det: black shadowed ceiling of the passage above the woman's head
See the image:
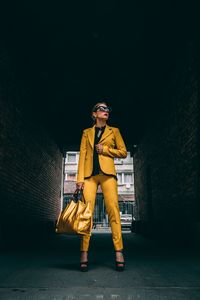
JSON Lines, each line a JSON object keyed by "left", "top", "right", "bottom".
{"left": 0, "top": 0, "right": 195, "bottom": 150}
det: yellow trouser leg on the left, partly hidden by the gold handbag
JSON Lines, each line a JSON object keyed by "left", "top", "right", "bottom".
{"left": 80, "top": 175, "right": 98, "bottom": 251}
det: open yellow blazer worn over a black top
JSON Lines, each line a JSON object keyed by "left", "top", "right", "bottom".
{"left": 77, "top": 124, "right": 127, "bottom": 182}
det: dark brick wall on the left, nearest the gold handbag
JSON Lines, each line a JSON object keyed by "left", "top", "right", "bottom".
{"left": 0, "top": 48, "right": 63, "bottom": 246}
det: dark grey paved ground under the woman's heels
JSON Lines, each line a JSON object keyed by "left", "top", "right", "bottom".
{"left": 0, "top": 231, "right": 200, "bottom": 300}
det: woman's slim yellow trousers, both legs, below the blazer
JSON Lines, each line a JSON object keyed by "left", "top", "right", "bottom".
{"left": 80, "top": 173, "right": 123, "bottom": 251}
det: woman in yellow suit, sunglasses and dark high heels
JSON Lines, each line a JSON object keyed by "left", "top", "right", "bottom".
{"left": 76, "top": 102, "right": 127, "bottom": 271}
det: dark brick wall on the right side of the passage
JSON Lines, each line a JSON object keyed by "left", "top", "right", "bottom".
{"left": 134, "top": 45, "right": 200, "bottom": 238}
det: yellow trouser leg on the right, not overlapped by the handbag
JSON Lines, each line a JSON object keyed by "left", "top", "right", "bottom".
{"left": 100, "top": 175, "right": 123, "bottom": 250}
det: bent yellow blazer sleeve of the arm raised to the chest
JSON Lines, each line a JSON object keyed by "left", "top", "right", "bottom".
{"left": 102, "top": 128, "right": 127, "bottom": 158}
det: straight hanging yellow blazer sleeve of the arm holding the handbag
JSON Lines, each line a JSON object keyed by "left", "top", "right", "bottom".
{"left": 76, "top": 130, "right": 86, "bottom": 182}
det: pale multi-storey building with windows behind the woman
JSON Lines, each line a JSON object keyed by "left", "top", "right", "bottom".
{"left": 63, "top": 151, "right": 135, "bottom": 228}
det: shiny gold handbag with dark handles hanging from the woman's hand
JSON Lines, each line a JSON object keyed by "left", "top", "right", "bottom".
{"left": 55, "top": 189, "right": 92, "bottom": 235}
